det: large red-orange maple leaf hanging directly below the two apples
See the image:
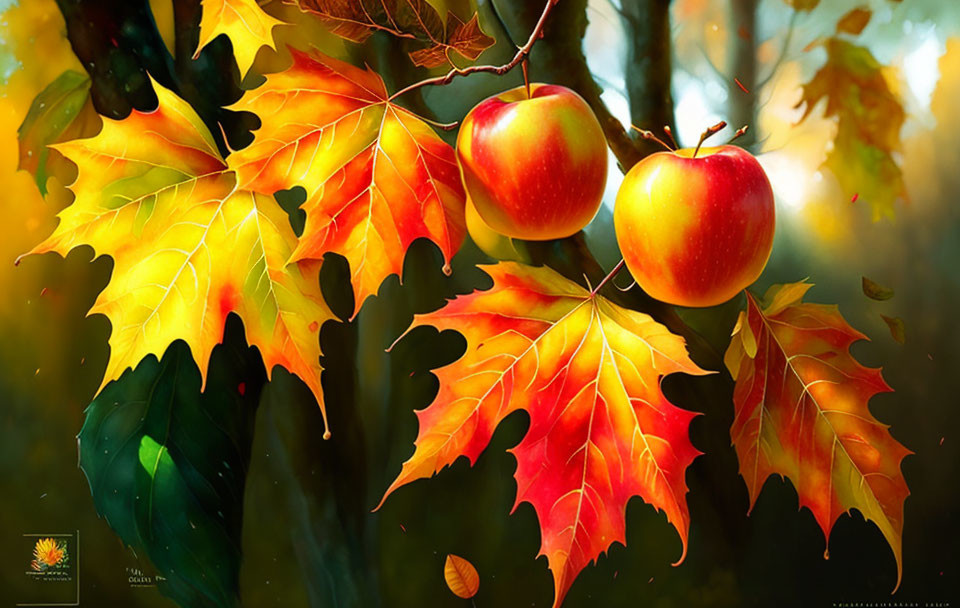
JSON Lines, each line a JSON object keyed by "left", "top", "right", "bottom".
{"left": 381, "top": 262, "right": 707, "bottom": 606}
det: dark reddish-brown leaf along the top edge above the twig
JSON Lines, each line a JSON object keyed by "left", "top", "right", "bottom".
{"left": 298, "top": 0, "right": 495, "bottom": 68}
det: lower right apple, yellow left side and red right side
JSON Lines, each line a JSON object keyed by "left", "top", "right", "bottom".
{"left": 613, "top": 145, "right": 776, "bottom": 306}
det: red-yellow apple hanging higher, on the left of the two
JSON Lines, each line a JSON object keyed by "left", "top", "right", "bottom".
{"left": 457, "top": 84, "right": 607, "bottom": 240}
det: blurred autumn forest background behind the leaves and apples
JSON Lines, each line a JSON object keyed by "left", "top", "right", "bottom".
{"left": 0, "top": 0, "right": 960, "bottom": 608}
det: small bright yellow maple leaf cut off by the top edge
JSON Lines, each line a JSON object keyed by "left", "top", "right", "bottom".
{"left": 193, "top": 0, "right": 283, "bottom": 78}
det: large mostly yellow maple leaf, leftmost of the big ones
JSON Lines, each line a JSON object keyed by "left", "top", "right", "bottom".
{"left": 24, "top": 82, "right": 333, "bottom": 432}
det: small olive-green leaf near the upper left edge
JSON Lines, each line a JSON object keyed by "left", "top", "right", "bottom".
{"left": 17, "top": 70, "right": 97, "bottom": 196}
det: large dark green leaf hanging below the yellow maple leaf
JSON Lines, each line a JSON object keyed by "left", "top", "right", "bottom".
{"left": 79, "top": 320, "right": 265, "bottom": 608}
